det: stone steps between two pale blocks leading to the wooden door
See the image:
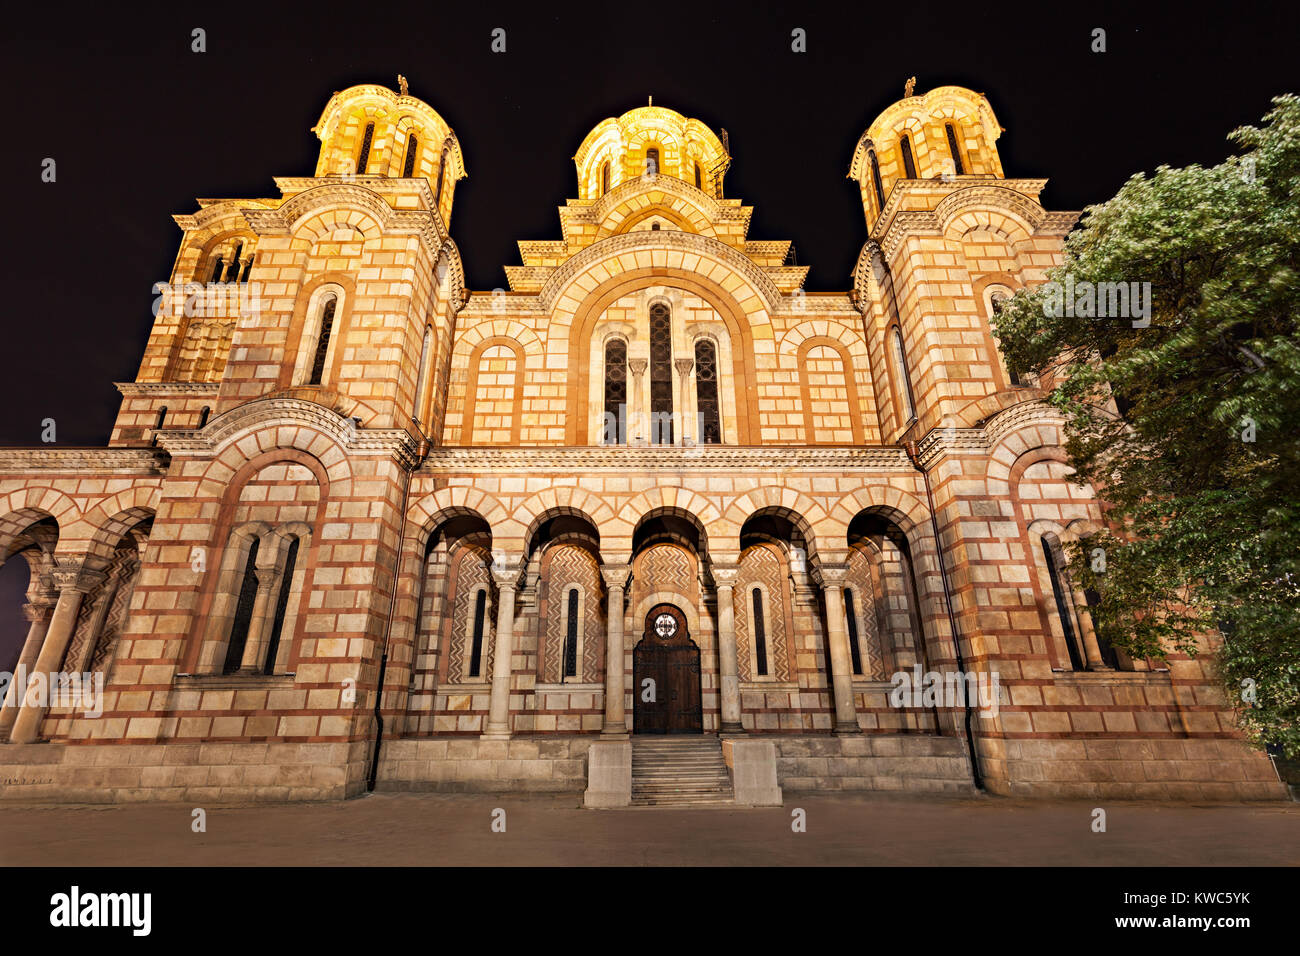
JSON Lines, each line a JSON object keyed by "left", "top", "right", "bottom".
{"left": 632, "top": 734, "right": 736, "bottom": 806}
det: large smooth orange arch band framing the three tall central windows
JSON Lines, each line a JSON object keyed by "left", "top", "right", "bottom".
{"left": 553, "top": 267, "right": 761, "bottom": 445}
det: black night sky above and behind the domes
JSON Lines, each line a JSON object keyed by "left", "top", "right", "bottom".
{"left": 0, "top": 0, "right": 1300, "bottom": 650}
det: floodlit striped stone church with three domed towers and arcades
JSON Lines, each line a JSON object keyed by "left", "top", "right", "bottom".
{"left": 0, "top": 79, "right": 1286, "bottom": 806}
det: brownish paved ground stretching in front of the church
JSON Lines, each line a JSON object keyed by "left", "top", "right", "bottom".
{"left": 0, "top": 793, "right": 1300, "bottom": 866}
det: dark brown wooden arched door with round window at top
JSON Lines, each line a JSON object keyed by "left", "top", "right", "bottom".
{"left": 632, "top": 604, "right": 705, "bottom": 734}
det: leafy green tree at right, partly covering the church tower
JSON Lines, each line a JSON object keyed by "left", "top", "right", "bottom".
{"left": 996, "top": 95, "right": 1300, "bottom": 756}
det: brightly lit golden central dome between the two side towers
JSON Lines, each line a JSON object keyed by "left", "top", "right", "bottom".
{"left": 573, "top": 105, "right": 731, "bottom": 199}
